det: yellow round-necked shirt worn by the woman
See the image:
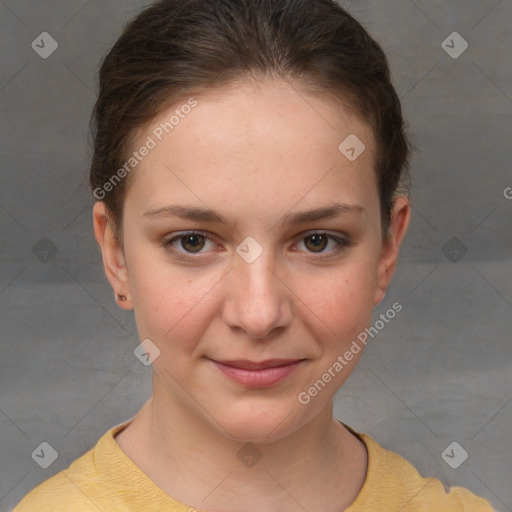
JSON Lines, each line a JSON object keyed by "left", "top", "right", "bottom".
{"left": 12, "top": 420, "right": 494, "bottom": 512}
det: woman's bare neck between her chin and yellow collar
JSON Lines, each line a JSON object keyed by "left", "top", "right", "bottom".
{"left": 123, "top": 373, "right": 367, "bottom": 512}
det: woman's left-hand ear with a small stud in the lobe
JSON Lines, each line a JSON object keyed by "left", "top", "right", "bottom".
{"left": 93, "top": 201, "right": 133, "bottom": 310}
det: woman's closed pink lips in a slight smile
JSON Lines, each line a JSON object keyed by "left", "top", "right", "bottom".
{"left": 211, "top": 359, "right": 304, "bottom": 388}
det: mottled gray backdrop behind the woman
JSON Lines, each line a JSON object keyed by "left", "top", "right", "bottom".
{"left": 0, "top": 0, "right": 512, "bottom": 512}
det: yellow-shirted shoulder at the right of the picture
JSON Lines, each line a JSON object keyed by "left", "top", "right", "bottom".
{"left": 347, "top": 434, "right": 494, "bottom": 512}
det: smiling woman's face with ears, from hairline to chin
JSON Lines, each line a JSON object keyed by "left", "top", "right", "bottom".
{"left": 94, "top": 78, "right": 408, "bottom": 441}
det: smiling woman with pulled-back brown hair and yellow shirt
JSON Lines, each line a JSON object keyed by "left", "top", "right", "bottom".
{"left": 15, "top": 0, "right": 492, "bottom": 512}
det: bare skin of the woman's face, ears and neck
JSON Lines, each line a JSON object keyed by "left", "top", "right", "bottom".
{"left": 93, "top": 80, "right": 410, "bottom": 512}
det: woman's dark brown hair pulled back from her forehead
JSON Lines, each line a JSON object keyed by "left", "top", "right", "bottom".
{"left": 90, "top": 0, "right": 410, "bottom": 238}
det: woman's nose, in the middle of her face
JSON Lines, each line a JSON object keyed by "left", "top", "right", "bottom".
{"left": 223, "top": 245, "right": 293, "bottom": 339}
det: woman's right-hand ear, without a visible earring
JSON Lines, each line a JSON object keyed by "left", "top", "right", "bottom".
{"left": 373, "top": 195, "right": 411, "bottom": 305}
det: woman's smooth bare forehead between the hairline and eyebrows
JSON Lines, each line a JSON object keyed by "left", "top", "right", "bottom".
{"left": 123, "top": 80, "right": 376, "bottom": 223}
